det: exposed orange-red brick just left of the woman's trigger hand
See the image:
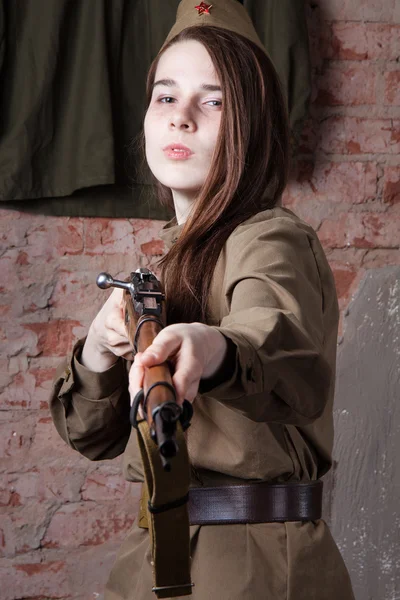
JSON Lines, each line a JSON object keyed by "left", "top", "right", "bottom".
{"left": 24, "top": 319, "right": 81, "bottom": 356}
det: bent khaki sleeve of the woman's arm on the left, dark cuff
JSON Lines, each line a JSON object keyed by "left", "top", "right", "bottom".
{"left": 50, "top": 339, "right": 131, "bottom": 460}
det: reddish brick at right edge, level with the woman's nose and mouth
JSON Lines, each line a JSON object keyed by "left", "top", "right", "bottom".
{"left": 319, "top": 116, "right": 400, "bottom": 154}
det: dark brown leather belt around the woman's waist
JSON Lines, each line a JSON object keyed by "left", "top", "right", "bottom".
{"left": 139, "top": 480, "right": 323, "bottom": 528}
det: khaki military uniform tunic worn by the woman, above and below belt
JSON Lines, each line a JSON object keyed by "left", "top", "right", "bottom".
{"left": 51, "top": 207, "right": 353, "bottom": 600}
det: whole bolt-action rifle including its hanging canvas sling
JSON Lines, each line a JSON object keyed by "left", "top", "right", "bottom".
{"left": 97, "top": 268, "right": 194, "bottom": 598}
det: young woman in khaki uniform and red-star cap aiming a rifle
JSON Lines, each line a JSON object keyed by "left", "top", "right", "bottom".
{"left": 51, "top": 0, "right": 353, "bottom": 600}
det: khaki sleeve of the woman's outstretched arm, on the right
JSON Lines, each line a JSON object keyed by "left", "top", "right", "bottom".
{"left": 199, "top": 218, "right": 336, "bottom": 425}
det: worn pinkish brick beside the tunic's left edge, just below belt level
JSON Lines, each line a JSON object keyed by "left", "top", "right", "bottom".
{"left": 42, "top": 502, "right": 134, "bottom": 550}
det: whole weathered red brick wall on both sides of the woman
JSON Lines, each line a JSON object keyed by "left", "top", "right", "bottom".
{"left": 0, "top": 0, "right": 400, "bottom": 600}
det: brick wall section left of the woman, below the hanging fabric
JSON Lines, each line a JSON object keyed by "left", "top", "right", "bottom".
{"left": 0, "top": 210, "right": 163, "bottom": 600}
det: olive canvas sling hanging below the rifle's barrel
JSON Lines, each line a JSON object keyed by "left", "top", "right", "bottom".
{"left": 137, "top": 420, "right": 193, "bottom": 598}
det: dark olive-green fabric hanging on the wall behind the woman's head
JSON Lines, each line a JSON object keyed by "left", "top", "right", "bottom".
{"left": 0, "top": 0, "right": 310, "bottom": 219}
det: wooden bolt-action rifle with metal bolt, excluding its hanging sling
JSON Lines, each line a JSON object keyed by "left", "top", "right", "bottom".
{"left": 97, "top": 268, "right": 193, "bottom": 471}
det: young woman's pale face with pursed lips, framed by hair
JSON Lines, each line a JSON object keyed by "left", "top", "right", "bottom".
{"left": 144, "top": 40, "right": 222, "bottom": 198}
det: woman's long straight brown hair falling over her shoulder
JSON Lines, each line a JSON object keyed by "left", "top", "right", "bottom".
{"left": 146, "top": 27, "right": 289, "bottom": 324}
